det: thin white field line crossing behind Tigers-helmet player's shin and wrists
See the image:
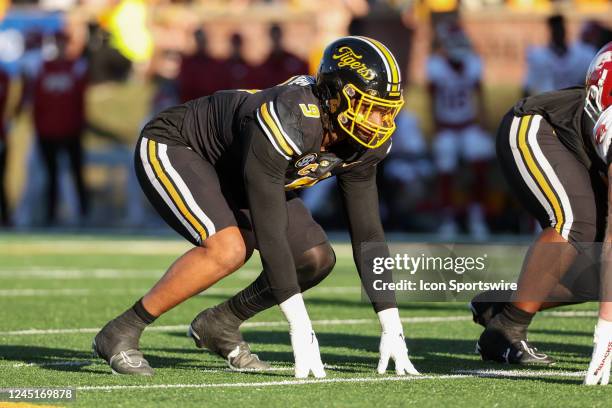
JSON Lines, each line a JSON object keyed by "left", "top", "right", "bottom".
{"left": 0, "top": 286, "right": 361, "bottom": 297}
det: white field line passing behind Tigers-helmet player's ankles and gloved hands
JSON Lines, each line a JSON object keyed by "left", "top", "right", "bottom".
{"left": 0, "top": 316, "right": 471, "bottom": 336}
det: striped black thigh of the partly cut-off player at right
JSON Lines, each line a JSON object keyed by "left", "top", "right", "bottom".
{"left": 497, "top": 113, "right": 598, "bottom": 244}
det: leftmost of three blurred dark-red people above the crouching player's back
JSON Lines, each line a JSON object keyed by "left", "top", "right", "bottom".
{"left": 177, "top": 29, "right": 228, "bottom": 102}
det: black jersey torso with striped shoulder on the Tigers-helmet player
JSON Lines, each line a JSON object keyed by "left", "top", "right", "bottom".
{"left": 146, "top": 76, "right": 391, "bottom": 190}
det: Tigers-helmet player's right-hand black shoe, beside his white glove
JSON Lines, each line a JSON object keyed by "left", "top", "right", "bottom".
{"left": 187, "top": 303, "right": 270, "bottom": 370}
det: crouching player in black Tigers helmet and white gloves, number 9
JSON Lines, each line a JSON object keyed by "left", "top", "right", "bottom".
{"left": 93, "top": 37, "right": 416, "bottom": 377}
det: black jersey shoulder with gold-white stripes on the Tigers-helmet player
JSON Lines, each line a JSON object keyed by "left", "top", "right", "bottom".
{"left": 256, "top": 87, "right": 323, "bottom": 160}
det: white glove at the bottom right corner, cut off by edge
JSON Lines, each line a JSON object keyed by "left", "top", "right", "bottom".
{"left": 584, "top": 319, "right": 612, "bottom": 385}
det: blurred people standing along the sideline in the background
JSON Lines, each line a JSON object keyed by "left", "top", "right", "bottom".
{"left": 0, "top": 0, "right": 610, "bottom": 240}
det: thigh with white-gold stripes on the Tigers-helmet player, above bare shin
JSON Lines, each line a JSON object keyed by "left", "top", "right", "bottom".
{"left": 135, "top": 136, "right": 236, "bottom": 245}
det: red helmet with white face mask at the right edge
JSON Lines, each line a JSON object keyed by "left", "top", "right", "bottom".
{"left": 584, "top": 42, "right": 612, "bottom": 123}
